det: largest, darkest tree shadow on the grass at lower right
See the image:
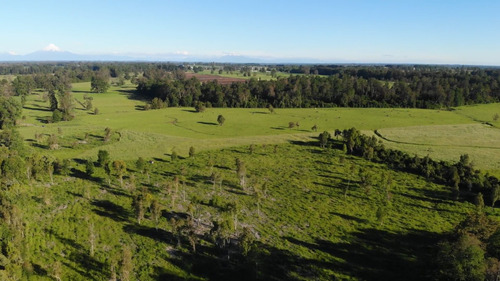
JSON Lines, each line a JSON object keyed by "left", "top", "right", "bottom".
{"left": 286, "top": 229, "right": 440, "bottom": 280}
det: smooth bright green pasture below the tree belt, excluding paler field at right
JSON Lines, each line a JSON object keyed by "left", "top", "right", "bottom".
{"left": 20, "top": 83, "right": 486, "bottom": 164}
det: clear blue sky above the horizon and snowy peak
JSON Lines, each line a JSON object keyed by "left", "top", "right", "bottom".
{"left": 0, "top": 0, "right": 500, "bottom": 65}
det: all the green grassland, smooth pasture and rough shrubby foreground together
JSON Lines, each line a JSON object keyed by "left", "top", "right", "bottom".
{"left": 0, "top": 80, "right": 500, "bottom": 281}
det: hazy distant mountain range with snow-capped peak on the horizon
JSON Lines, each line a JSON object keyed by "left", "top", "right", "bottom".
{"left": 0, "top": 47, "right": 324, "bottom": 64}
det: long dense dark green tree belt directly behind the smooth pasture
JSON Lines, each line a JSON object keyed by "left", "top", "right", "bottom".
{"left": 137, "top": 68, "right": 500, "bottom": 108}
